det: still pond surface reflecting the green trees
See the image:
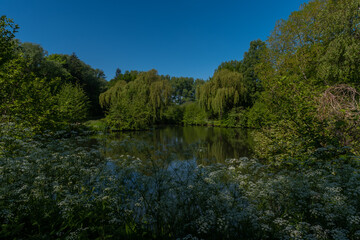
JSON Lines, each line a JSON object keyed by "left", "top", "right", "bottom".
{"left": 97, "top": 126, "right": 252, "bottom": 165}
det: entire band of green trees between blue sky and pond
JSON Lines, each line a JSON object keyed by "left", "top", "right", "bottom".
{"left": 0, "top": 0, "right": 360, "bottom": 156}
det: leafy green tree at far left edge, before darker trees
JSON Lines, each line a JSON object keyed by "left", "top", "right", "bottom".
{"left": 0, "top": 54, "right": 57, "bottom": 130}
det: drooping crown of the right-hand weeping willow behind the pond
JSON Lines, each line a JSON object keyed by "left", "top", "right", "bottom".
{"left": 198, "top": 69, "right": 248, "bottom": 118}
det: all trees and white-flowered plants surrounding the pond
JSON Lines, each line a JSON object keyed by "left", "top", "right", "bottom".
{"left": 0, "top": 0, "right": 360, "bottom": 239}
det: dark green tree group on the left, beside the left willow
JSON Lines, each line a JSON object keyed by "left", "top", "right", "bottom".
{"left": 0, "top": 16, "right": 107, "bottom": 131}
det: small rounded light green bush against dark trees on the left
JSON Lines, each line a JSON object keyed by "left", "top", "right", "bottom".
{"left": 56, "top": 83, "right": 89, "bottom": 123}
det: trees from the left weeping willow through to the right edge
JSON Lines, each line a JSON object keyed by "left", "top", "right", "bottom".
{"left": 100, "top": 0, "right": 360, "bottom": 157}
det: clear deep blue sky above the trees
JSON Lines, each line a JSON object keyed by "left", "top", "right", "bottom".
{"left": 0, "top": 0, "right": 308, "bottom": 80}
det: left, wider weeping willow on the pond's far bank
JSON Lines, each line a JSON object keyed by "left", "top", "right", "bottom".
{"left": 100, "top": 70, "right": 172, "bottom": 130}
